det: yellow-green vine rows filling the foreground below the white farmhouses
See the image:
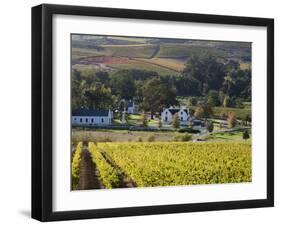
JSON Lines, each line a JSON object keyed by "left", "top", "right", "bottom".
{"left": 72, "top": 142, "right": 252, "bottom": 188}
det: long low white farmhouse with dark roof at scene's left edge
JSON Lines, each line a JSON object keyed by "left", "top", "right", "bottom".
{"left": 72, "top": 108, "right": 113, "bottom": 126}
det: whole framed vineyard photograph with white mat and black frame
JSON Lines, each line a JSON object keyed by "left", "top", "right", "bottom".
{"left": 32, "top": 4, "right": 274, "bottom": 221}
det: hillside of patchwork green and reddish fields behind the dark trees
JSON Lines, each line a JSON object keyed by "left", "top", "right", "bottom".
{"left": 72, "top": 35, "right": 251, "bottom": 75}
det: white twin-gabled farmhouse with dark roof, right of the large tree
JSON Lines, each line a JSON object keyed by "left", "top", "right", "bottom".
{"left": 161, "top": 106, "right": 190, "bottom": 124}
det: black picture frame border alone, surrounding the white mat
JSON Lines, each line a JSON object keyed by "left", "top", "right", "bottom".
{"left": 32, "top": 4, "right": 274, "bottom": 221}
